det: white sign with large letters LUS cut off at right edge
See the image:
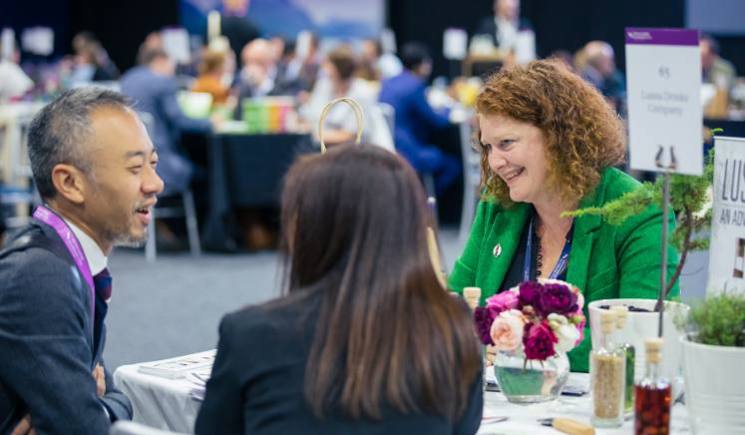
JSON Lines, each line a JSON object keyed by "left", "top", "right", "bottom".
{"left": 707, "top": 137, "right": 745, "bottom": 294}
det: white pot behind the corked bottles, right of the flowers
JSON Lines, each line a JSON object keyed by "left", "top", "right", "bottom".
{"left": 587, "top": 299, "right": 690, "bottom": 384}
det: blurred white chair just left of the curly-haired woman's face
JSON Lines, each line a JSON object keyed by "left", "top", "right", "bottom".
{"left": 458, "top": 116, "right": 481, "bottom": 246}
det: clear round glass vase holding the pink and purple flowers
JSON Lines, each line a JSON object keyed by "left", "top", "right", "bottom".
{"left": 494, "top": 351, "right": 569, "bottom": 404}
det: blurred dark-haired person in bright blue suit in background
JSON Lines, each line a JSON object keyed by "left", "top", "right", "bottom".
{"left": 379, "top": 42, "right": 462, "bottom": 191}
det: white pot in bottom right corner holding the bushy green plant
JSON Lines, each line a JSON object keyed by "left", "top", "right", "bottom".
{"left": 680, "top": 336, "right": 745, "bottom": 435}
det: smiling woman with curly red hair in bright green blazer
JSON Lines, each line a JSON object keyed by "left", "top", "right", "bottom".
{"left": 450, "top": 60, "right": 677, "bottom": 371}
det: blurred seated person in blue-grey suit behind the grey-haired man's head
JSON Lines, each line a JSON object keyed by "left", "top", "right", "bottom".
{"left": 121, "top": 48, "right": 212, "bottom": 196}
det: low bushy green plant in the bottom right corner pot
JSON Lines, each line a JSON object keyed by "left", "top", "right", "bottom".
{"left": 688, "top": 293, "right": 745, "bottom": 347}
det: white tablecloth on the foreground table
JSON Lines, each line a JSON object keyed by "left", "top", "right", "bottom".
{"left": 114, "top": 354, "right": 689, "bottom": 435}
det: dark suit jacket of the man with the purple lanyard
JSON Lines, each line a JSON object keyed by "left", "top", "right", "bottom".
{"left": 0, "top": 221, "right": 132, "bottom": 435}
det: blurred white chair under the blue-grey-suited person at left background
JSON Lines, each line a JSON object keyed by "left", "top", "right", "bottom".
{"left": 139, "top": 112, "right": 202, "bottom": 262}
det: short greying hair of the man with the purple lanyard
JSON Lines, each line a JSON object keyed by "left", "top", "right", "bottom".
{"left": 28, "top": 86, "right": 132, "bottom": 199}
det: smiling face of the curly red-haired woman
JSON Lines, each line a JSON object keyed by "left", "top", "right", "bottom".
{"left": 479, "top": 114, "right": 555, "bottom": 204}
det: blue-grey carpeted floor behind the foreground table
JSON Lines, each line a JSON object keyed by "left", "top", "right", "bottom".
{"left": 105, "top": 229, "right": 708, "bottom": 371}
